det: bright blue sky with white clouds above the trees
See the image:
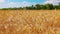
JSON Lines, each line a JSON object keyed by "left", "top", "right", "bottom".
{"left": 0, "top": 0, "right": 60, "bottom": 8}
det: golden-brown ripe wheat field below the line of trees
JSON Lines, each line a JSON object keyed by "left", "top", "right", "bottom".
{"left": 0, "top": 10, "right": 60, "bottom": 34}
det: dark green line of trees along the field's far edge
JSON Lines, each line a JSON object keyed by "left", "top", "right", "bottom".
{"left": 1, "top": 3, "right": 60, "bottom": 10}
